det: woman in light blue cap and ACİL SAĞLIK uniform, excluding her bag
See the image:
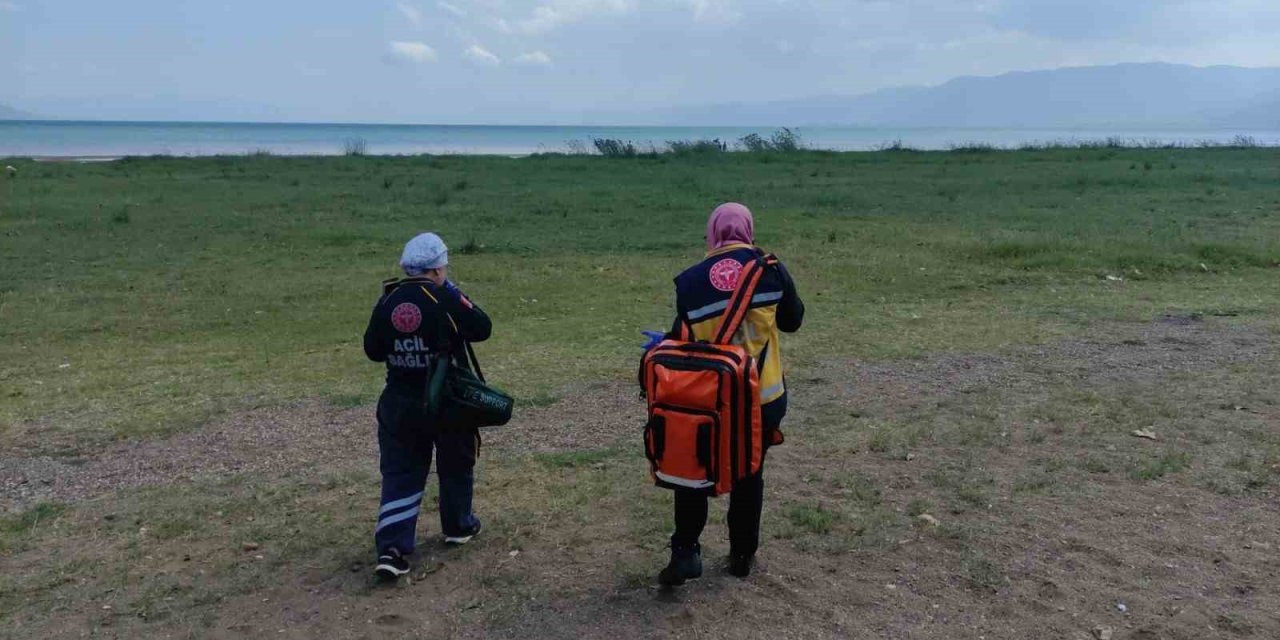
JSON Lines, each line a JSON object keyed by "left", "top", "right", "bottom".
{"left": 365, "top": 233, "right": 492, "bottom": 579}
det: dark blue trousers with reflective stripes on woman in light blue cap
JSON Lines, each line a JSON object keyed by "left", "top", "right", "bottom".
{"left": 374, "top": 389, "right": 480, "bottom": 554}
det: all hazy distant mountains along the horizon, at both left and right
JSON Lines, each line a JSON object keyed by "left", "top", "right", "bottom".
{"left": 0, "top": 63, "right": 1280, "bottom": 131}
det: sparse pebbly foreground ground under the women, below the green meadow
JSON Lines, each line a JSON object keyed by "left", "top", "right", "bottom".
{"left": 0, "top": 317, "right": 1280, "bottom": 639}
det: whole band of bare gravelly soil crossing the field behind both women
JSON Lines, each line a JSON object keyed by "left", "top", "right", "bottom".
{"left": 0, "top": 321, "right": 1274, "bottom": 512}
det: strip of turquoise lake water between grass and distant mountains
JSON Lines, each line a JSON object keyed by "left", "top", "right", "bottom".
{"left": 0, "top": 120, "right": 1280, "bottom": 157}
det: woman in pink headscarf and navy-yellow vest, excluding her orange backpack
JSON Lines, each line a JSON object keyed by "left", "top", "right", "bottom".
{"left": 658, "top": 202, "right": 804, "bottom": 586}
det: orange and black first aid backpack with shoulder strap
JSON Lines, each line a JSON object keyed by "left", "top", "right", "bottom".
{"left": 640, "top": 255, "right": 778, "bottom": 495}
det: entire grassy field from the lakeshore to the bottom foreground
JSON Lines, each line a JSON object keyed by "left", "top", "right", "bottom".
{"left": 0, "top": 148, "right": 1280, "bottom": 637}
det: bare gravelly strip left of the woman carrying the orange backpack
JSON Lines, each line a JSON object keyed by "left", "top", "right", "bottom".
{"left": 0, "top": 383, "right": 644, "bottom": 513}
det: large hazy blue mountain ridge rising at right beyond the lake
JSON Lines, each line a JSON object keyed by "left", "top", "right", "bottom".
{"left": 636, "top": 63, "right": 1280, "bottom": 129}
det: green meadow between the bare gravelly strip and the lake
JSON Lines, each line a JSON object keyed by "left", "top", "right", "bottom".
{"left": 0, "top": 148, "right": 1280, "bottom": 440}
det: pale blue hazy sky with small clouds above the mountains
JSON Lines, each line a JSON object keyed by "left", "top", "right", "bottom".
{"left": 0, "top": 0, "right": 1280, "bottom": 123}
